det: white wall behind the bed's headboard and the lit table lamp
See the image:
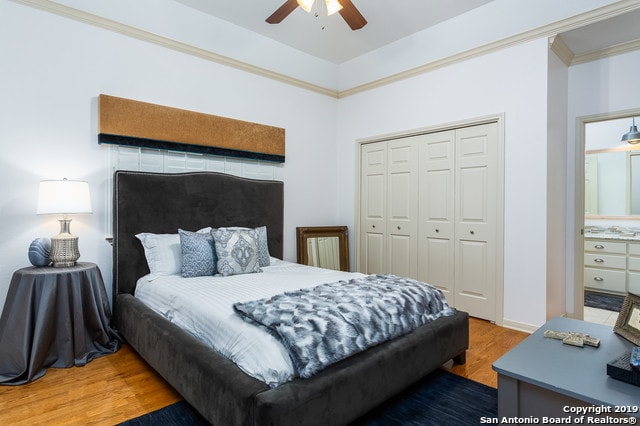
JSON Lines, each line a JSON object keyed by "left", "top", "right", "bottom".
{"left": 0, "top": 1, "right": 339, "bottom": 312}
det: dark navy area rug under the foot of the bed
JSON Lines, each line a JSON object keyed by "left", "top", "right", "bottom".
{"left": 116, "top": 370, "right": 498, "bottom": 426}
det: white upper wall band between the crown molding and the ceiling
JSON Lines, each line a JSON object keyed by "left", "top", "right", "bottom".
{"left": 33, "top": 0, "right": 623, "bottom": 91}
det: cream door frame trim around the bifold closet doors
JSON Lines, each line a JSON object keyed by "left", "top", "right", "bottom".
{"left": 354, "top": 113, "right": 505, "bottom": 326}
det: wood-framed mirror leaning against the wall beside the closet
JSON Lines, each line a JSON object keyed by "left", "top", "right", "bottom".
{"left": 296, "top": 226, "right": 349, "bottom": 271}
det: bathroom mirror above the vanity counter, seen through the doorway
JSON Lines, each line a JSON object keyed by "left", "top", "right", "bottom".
{"left": 584, "top": 118, "right": 640, "bottom": 219}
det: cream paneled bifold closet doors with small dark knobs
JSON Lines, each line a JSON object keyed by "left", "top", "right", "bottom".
{"left": 357, "top": 122, "right": 503, "bottom": 321}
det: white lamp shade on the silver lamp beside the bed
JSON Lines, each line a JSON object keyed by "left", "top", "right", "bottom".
{"left": 37, "top": 179, "right": 91, "bottom": 214}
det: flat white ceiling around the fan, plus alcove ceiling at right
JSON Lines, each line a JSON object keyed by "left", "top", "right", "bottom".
{"left": 175, "top": 0, "right": 640, "bottom": 64}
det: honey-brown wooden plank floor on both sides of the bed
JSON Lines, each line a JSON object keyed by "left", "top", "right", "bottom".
{"left": 0, "top": 318, "right": 528, "bottom": 426}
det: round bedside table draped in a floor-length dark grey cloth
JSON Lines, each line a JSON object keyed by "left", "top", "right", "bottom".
{"left": 0, "top": 263, "right": 120, "bottom": 385}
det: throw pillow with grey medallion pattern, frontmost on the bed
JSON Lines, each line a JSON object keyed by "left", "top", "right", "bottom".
{"left": 211, "top": 228, "right": 262, "bottom": 277}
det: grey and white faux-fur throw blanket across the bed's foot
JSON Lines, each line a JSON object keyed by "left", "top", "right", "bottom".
{"left": 233, "top": 275, "right": 455, "bottom": 378}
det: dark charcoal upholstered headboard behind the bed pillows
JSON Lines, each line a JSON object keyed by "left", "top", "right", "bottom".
{"left": 113, "top": 171, "right": 284, "bottom": 300}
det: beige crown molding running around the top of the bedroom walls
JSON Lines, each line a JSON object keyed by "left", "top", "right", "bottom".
{"left": 11, "top": 0, "right": 640, "bottom": 98}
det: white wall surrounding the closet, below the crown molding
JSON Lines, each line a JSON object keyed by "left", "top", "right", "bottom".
{"left": 338, "top": 39, "right": 547, "bottom": 326}
